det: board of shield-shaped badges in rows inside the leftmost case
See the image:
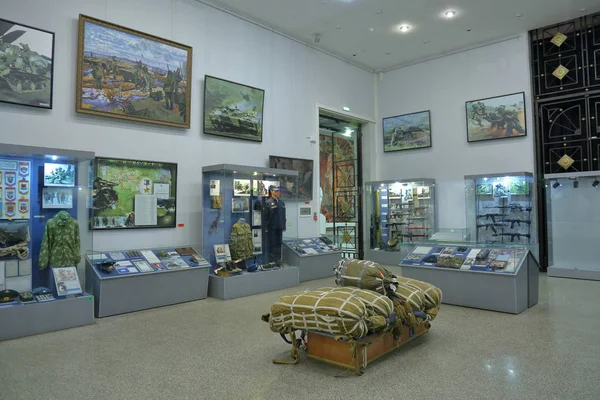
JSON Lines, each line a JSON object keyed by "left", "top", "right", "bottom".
{"left": 0, "top": 159, "right": 31, "bottom": 220}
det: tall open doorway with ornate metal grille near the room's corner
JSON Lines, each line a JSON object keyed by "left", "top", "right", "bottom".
{"left": 319, "top": 112, "right": 363, "bottom": 259}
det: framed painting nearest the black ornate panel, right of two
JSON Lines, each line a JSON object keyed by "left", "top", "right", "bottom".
{"left": 466, "top": 92, "right": 527, "bottom": 142}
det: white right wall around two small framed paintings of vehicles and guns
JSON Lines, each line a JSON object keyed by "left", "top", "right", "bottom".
{"left": 375, "top": 34, "right": 534, "bottom": 228}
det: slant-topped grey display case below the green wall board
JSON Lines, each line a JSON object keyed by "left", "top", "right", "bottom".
{"left": 86, "top": 246, "right": 210, "bottom": 318}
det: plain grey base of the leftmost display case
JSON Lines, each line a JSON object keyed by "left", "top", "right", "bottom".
{"left": 0, "top": 293, "right": 94, "bottom": 340}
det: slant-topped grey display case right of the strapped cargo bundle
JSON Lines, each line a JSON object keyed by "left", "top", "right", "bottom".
{"left": 400, "top": 243, "right": 539, "bottom": 314}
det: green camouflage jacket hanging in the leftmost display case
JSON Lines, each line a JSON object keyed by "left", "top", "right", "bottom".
{"left": 39, "top": 211, "right": 81, "bottom": 269}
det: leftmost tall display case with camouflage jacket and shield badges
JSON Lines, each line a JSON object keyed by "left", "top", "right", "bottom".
{"left": 0, "top": 144, "right": 94, "bottom": 340}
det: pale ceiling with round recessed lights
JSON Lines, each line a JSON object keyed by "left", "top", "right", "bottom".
{"left": 198, "top": 0, "right": 600, "bottom": 71}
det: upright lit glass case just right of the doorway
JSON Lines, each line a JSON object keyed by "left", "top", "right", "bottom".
{"left": 365, "top": 178, "right": 437, "bottom": 251}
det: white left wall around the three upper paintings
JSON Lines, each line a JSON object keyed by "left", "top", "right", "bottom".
{"left": 0, "top": 0, "right": 375, "bottom": 249}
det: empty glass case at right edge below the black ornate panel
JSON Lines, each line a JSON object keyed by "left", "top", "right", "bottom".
{"left": 545, "top": 172, "right": 600, "bottom": 280}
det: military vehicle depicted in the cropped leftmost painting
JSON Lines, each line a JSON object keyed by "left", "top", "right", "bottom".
{"left": 0, "top": 41, "right": 51, "bottom": 93}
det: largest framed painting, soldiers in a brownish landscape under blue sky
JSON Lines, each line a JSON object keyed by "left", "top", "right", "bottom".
{"left": 77, "top": 15, "right": 192, "bottom": 128}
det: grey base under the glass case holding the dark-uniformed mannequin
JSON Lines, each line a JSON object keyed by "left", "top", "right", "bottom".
{"left": 208, "top": 267, "right": 298, "bottom": 300}
